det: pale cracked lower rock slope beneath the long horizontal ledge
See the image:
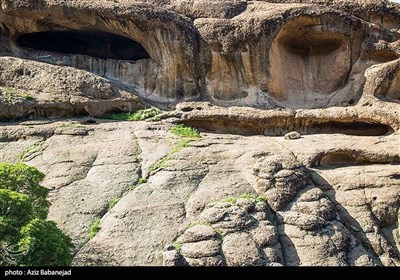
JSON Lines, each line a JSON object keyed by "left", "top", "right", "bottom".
{"left": 0, "top": 117, "right": 400, "bottom": 266}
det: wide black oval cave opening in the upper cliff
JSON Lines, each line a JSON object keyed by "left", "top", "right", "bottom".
{"left": 17, "top": 30, "right": 150, "bottom": 61}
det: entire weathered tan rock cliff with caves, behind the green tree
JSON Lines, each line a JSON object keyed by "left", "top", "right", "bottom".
{"left": 0, "top": 0, "right": 400, "bottom": 266}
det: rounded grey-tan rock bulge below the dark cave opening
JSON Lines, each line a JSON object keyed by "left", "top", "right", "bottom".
{"left": 0, "top": 57, "right": 145, "bottom": 120}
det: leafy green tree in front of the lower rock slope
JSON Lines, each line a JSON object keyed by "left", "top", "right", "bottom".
{"left": 0, "top": 163, "right": 72, "bottom": 266}
